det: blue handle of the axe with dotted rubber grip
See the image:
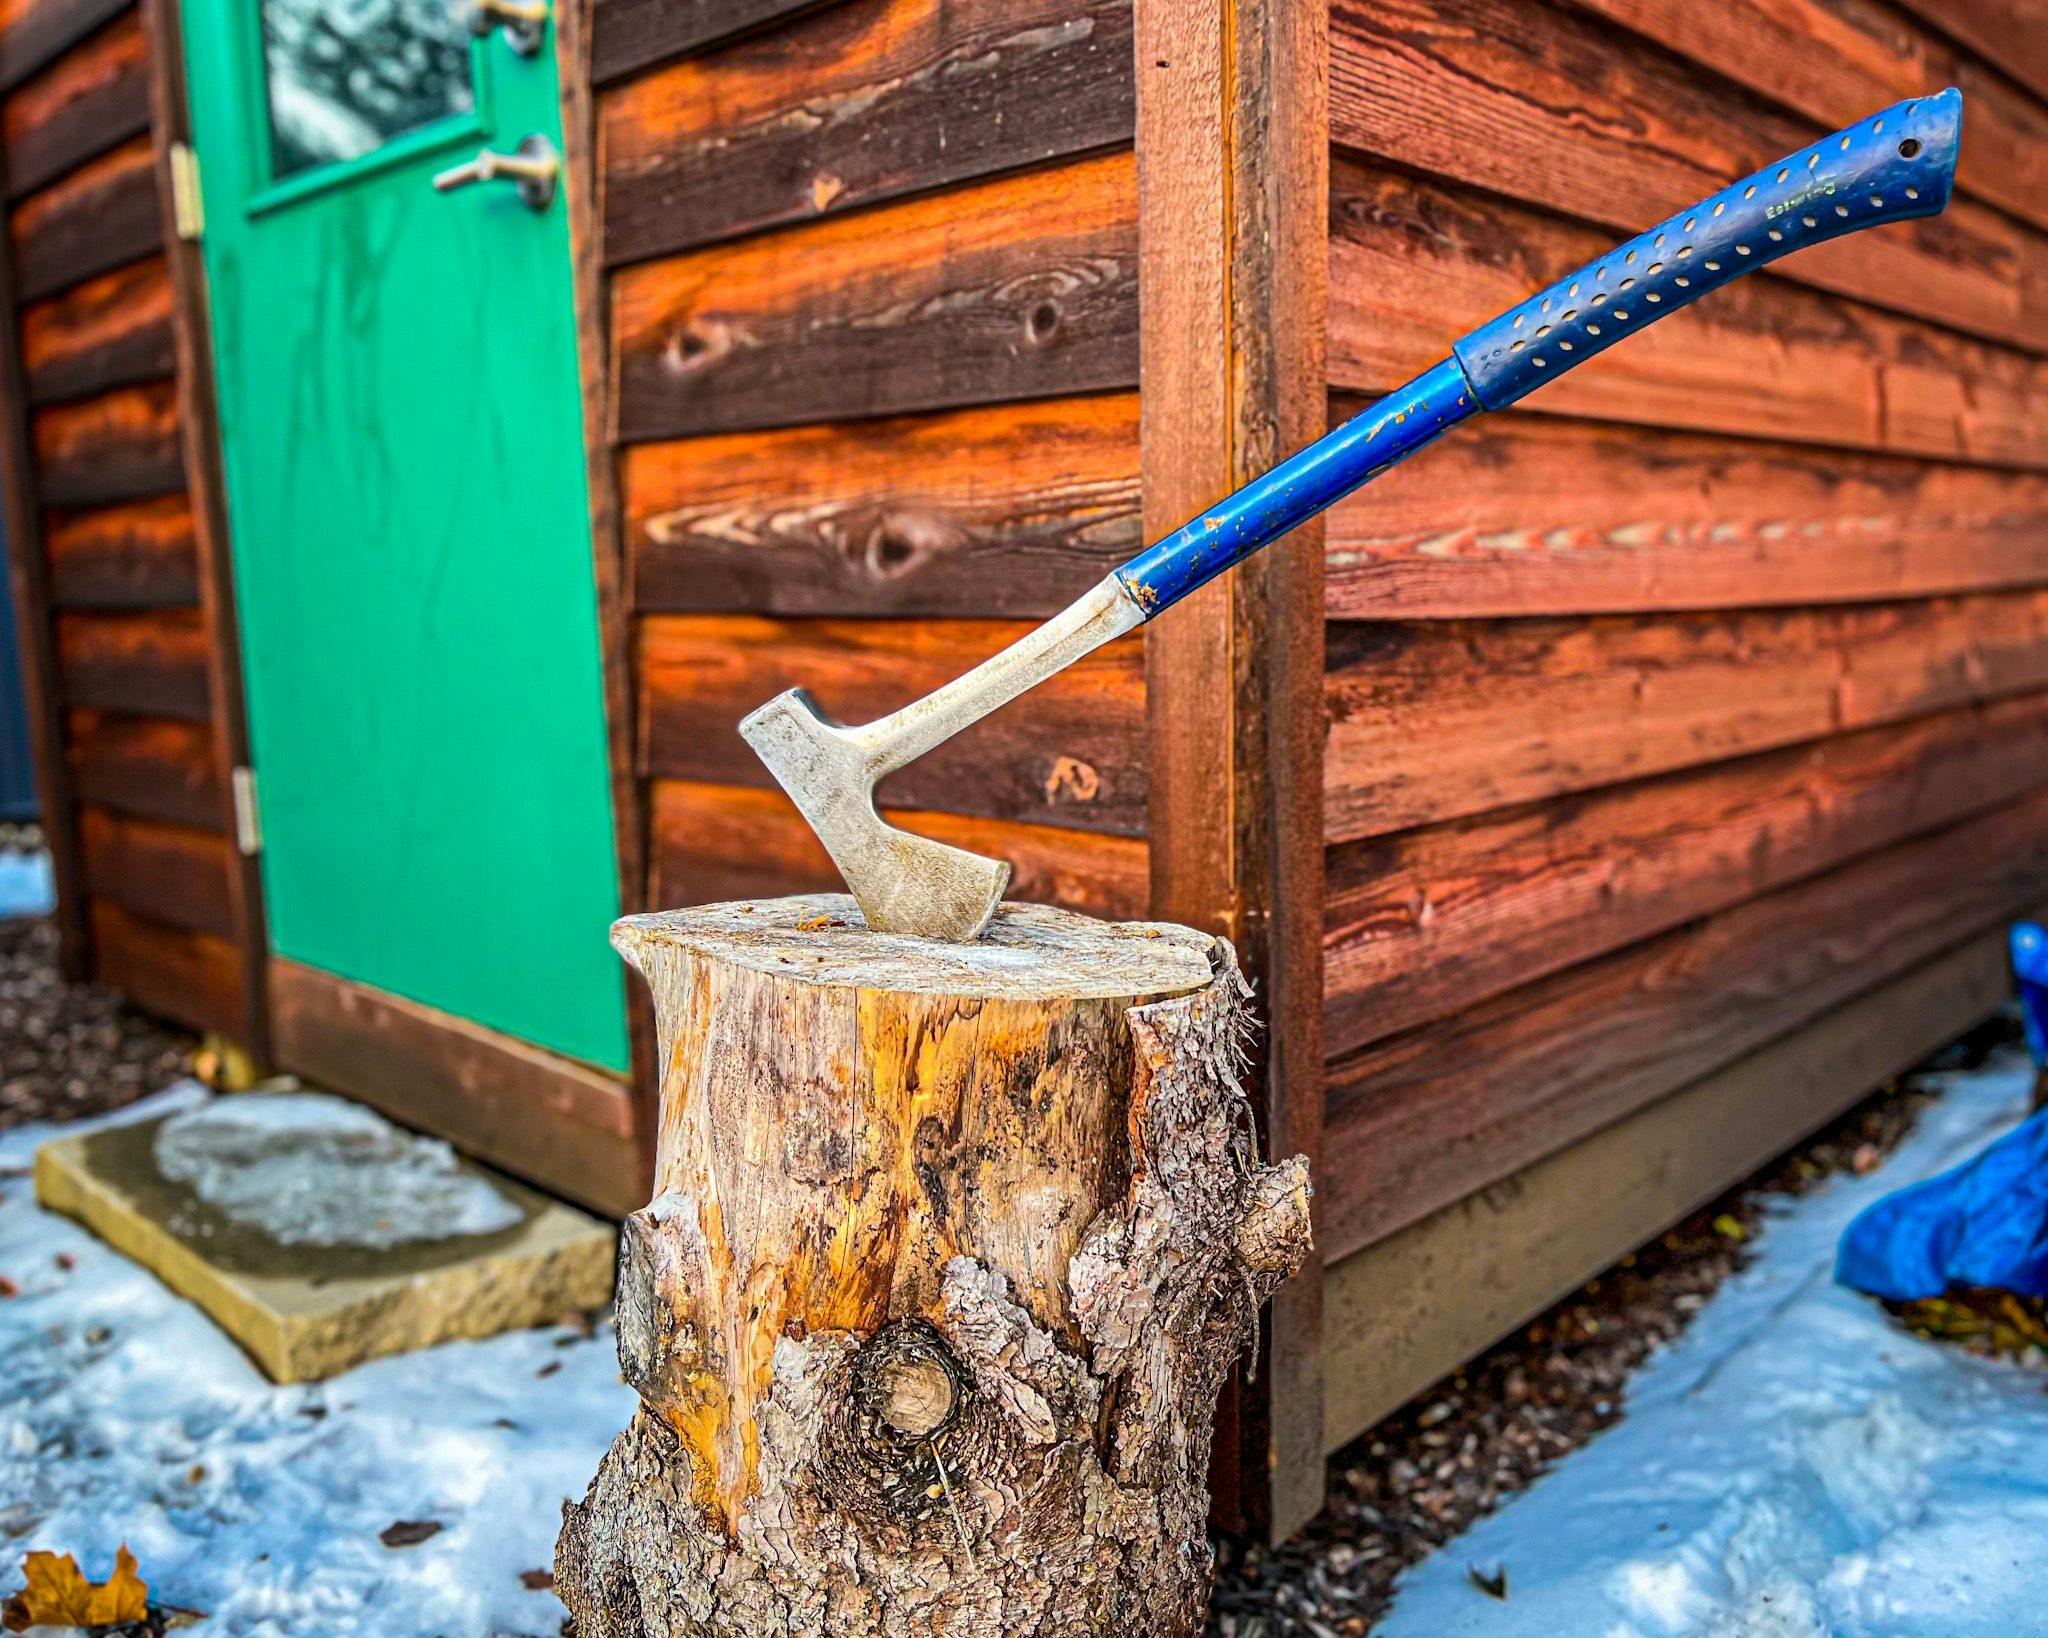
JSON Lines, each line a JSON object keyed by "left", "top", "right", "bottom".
{"left": 1116, "top": 88, "right": 1962, "bottom": 620}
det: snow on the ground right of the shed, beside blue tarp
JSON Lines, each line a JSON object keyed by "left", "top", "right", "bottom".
{"left": 1378, "top": 1059, "right": 2048, "bottom": 1638}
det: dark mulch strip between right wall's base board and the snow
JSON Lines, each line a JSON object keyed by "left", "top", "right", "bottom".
{"left": 1208, "top": 1003, "right": 2019, "bottom": 1638}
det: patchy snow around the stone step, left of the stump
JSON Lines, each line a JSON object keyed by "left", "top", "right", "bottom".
{"left": 0, "top": 1085, "right": 633, "bottom": 1638}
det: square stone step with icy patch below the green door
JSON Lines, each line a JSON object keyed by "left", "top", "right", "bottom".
{"left": 35, "top": 1091, "right": 616, "bottom": 1382}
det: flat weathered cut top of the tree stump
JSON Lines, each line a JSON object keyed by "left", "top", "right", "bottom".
{"left": 612, "top": 893, "right": 1214, "bottom": 999}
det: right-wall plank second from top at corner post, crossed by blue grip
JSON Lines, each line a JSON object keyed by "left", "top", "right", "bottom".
{"left": 1329, "top": 162, "right": 2048, "bottom": 467}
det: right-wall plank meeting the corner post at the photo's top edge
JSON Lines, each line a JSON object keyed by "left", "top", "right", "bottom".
{"left": 1331, "top": 0, "right": 2048, "bottom": 350}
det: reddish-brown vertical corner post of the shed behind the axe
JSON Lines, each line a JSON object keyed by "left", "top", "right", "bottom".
{"left": 1137, "top": 0, "right": 1329, "bottom": 1536}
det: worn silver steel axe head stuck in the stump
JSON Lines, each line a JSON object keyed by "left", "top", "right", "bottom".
{"left": 739, "top": 688, "right": 1010, "bottom": 944}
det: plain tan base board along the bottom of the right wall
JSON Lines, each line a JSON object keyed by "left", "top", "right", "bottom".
{"left": 1323, "top": 928, "right": 2011, "bottom": 1452}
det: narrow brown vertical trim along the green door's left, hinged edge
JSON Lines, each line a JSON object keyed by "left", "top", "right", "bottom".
{"left": 141, "top": 0, "right": 270, "bottom": 1059}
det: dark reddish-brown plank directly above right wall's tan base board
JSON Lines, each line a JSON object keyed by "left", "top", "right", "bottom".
{"left": 1317, "top": 794, "right": 2048, "bottom": 1261}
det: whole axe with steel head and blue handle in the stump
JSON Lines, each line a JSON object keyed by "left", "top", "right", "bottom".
{"left": 739, "top": 90, "right": 1962, "bottom": 942}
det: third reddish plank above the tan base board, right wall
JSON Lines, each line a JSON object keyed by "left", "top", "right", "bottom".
{"left": 1323, "top": 590, "right": 2048, "bottom": 842}
